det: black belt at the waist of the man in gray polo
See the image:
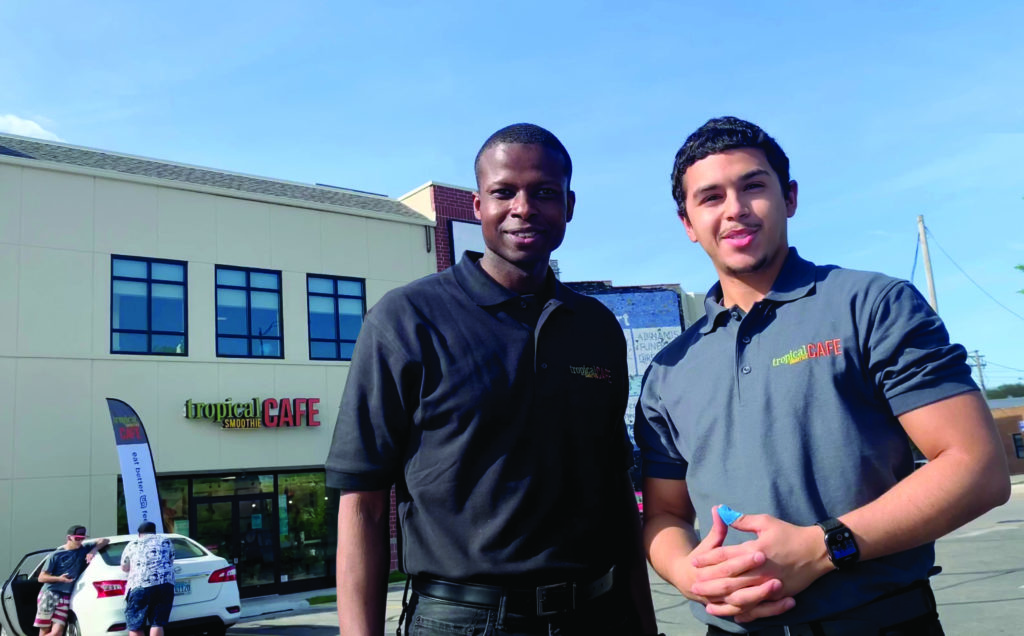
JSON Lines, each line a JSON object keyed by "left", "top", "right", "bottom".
{"left": 708, "top": 581, "right": 936, "bottom": 636}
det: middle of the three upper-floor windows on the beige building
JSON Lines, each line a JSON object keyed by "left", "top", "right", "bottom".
{"left": 217, "top": 265, "right": 285, "bottom": 357}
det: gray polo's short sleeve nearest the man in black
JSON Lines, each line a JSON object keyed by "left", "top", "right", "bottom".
{"left": 633, "top": 358, "right": 687, "bottom": 479}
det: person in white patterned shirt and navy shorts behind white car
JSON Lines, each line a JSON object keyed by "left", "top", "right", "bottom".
{"left": 121, "top": 521, "right": 174, "bottom": 636}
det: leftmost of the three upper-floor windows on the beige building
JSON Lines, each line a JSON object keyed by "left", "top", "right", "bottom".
{"left": 111, "top": 255, "right": 188, "bottom": 355}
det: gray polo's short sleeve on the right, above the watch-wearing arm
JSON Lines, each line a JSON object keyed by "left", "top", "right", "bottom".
{"left": 866, "top": 281, "right": 978, "bottom": 416}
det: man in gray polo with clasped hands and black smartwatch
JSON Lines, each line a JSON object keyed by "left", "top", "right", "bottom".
{"left": 635, "top": 117, "right": 1010, "bottom": 636}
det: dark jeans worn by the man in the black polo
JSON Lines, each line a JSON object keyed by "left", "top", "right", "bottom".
{"left": 402, "top": 592, "right": 628, "bottom": 636}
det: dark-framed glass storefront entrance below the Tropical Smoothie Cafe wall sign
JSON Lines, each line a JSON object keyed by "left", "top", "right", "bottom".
{"left": 118, "top": 469, "right": 338, "bottom": 597}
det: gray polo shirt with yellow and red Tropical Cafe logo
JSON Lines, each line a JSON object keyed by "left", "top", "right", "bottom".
{"left": 635, "top": 248, "right": 977, "bottom": 632}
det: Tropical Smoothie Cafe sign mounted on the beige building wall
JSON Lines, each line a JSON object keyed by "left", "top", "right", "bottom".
{"left": 184, "top": 397, "right": 319, "bottom": 428}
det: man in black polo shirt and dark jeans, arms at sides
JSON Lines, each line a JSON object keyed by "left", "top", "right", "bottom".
{"left": 327, "top": 124, "right": 656, "bottom": 636}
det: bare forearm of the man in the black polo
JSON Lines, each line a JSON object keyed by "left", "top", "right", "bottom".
{"left": 337, "top": 491, "right": 390, "bottom": 636}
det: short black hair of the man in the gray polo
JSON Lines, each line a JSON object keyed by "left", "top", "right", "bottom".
{"left": 672, "top": 116, "right": 790, "bottom": 217}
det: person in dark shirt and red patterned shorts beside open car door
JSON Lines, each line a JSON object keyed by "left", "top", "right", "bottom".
{"left": 33, "top": 525, "right": 110, "bottom": 636}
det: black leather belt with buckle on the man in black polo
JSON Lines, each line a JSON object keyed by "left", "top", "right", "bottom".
{"left": 413, "top": 567, "right": 614, "bottom": 617}
